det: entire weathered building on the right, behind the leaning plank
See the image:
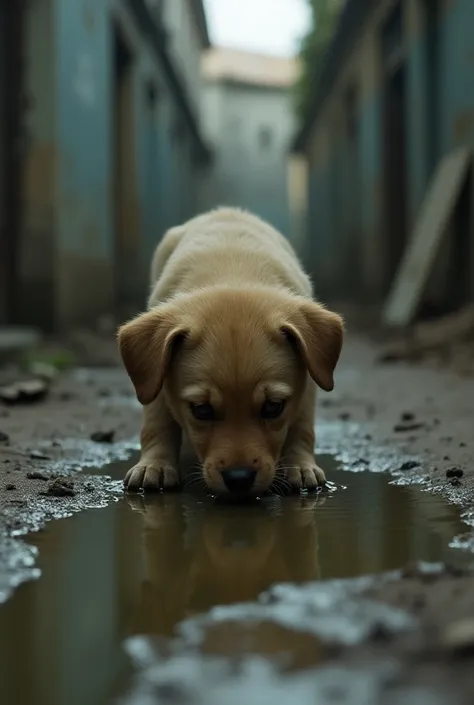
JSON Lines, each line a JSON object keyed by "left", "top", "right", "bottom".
{"left": 293, "top": 0, "right": 474, "bottom": 306}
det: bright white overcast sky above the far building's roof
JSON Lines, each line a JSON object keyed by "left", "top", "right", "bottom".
{"left": 204, "top": 0, "right": 309, "bottom": 55}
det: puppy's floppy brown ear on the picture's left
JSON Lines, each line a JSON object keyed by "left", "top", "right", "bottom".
{"left": 118, "top": 306, "right": 186, "bottom": 404}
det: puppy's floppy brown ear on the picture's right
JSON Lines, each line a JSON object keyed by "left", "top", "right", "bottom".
{"left": 281, "top": 300, "right": 344, "bottom": 392}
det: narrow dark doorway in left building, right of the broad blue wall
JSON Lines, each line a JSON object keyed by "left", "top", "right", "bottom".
{"left": 112, "top": 27, "right": 138, "bottom": 318}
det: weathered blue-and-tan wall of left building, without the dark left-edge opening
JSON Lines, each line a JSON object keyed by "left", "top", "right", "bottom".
{"left": 19, "top": 0, "right": 206, "bottom": 328}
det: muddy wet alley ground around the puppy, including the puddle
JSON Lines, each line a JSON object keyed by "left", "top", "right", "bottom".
{"left": 0, "top": 335, "right": 474, "bottom": 705}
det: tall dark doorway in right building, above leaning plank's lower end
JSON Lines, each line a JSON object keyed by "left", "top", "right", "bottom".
{"left": 382, "top": 4, "right": 408, "bottom": 290}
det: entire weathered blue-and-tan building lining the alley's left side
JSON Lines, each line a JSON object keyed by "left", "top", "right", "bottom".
{"left": 0, "top": 0, "right": 209, "bottom": 328}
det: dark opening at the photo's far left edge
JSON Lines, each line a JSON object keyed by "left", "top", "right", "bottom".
{"left": 0, "top": 0, "right": 23, "bottom": 323}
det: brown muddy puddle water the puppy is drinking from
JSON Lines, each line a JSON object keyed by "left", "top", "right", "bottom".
{"left": 0, "top": 459, "right": 468, "bottom": 705}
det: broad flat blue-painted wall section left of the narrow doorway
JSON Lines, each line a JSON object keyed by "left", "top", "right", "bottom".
{"left": 55, "top": 0, "right": 113, "bottom": 322}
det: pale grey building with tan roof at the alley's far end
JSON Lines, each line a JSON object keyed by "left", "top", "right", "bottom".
{"left": 202, "top": 47, "right": 297, "bottom": 234}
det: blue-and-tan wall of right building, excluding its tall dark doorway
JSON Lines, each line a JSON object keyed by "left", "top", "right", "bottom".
{"left": 304, "top": 0, "right": 474, "bottom": 301}
